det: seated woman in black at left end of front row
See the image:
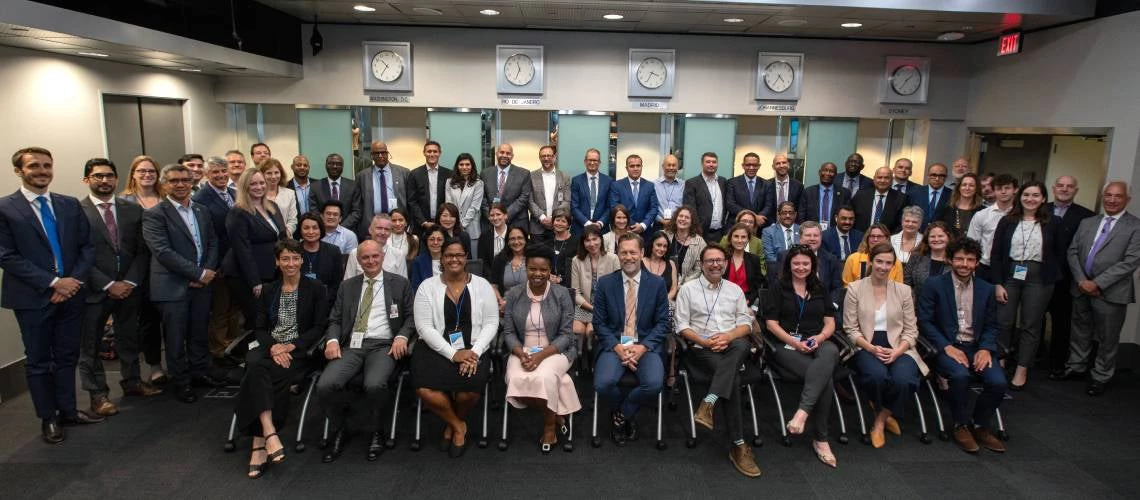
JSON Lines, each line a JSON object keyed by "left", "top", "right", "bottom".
{"left": 234, "top": 240, "right": 328, "bottom": 479}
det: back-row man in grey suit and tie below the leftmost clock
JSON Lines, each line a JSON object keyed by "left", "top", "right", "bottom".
{"left": 351, "top": 140, "right": 408, "bottom": 241}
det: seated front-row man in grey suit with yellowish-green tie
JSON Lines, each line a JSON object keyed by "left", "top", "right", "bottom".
{"left": 317, "top": 240, "right": 415, "bottom": 464}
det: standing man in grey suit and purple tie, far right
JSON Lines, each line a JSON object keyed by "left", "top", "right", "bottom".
{"left": 1050, "top": 181, "right": 1140, "bottom": 396}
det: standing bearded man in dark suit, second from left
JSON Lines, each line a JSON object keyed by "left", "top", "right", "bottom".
{"left": 79, "top": 158, "right": 160, "bottom": 417}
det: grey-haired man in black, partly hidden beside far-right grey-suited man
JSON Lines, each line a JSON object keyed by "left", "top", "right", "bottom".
{"left": 1047, "top": 175, "right": 1094, "bottom": 371}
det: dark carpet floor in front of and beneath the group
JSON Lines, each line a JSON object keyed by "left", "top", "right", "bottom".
{"left": 0, "top": 363, "right": 1140, "bottom": 499}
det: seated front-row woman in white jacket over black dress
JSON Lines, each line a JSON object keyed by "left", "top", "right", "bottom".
{"left": 412, "top": 239, "right": 499, "bottom": 457}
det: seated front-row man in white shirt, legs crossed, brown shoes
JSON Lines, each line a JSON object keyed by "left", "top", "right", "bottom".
{"left": 676, "top": 245, "right": 760, "bottom": 477}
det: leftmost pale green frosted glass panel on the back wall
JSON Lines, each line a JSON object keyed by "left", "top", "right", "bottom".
{"left": 296, "top": 109, "right": 353, "bottom": 179}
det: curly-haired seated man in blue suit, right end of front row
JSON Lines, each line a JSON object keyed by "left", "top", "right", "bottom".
{"left": 917, "top": 238, "right": 1007, "bottom": 453}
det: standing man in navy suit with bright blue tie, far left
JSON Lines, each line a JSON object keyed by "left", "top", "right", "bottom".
{"left": 0, "top": 147, "right": 100, "bottom": 444}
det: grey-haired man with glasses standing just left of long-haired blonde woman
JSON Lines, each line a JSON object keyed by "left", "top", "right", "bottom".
{"left": 193, "top": 157, "right": 242, "bottom": 359}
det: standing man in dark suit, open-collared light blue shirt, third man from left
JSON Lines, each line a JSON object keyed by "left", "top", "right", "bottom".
{"left": 143, "top": 165, "right": 221, "bottom": 403}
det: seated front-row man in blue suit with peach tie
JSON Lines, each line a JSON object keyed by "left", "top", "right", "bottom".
{"left": 594, "top": 232, "right": 669, "bottom": 446}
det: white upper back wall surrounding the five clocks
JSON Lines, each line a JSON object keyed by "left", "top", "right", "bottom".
{"left": 217, "top": 26, "right": 971, "bottom": 118}
